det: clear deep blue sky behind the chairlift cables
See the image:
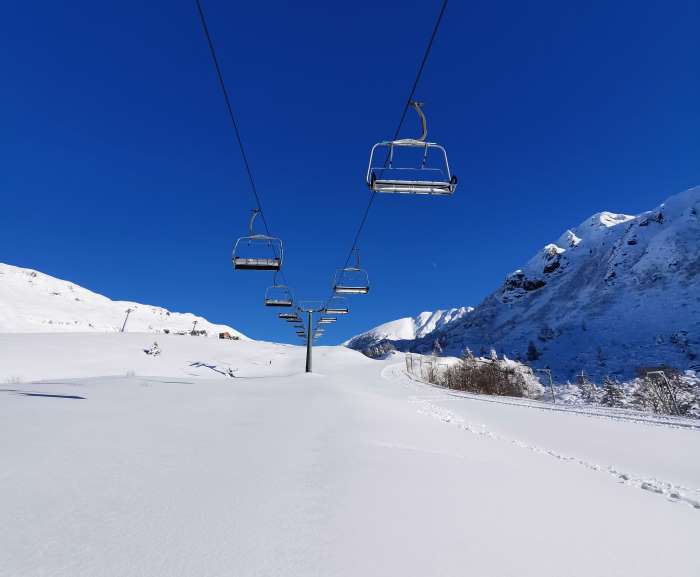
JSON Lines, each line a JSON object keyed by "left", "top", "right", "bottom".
{"left": 0, "top": 0, "right": 700, "bottom": 343}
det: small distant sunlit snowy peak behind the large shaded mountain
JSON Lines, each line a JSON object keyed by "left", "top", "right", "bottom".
{"left": 343, "top": 307, "right": 473, "bottom": 350}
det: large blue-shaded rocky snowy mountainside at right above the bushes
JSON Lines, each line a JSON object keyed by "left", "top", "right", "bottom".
{"left": 350, "top": 187, "right": 700, "bottom": 379}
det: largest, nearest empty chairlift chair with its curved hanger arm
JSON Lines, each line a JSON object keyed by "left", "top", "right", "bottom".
{"left": 366, "top": 101, "right": 457, "bottom": 195}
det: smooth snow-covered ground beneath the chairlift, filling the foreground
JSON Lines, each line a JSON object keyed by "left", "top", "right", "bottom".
{"left": 0, "top": 334, "right": 700, "bottom": 577}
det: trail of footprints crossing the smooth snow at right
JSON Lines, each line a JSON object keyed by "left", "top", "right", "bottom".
{"left": 409, "top": 397, "right": 700, "bottom": 510}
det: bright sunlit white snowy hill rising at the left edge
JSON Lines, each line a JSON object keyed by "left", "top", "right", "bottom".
{"left": 0, "top": 263, "right": 247, "bottom": 339}
